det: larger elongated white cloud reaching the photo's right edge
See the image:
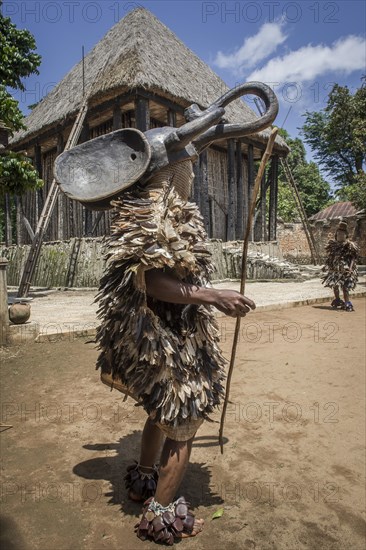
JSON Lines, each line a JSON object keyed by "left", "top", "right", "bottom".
{"left": 247, "top": 35, "right": 366, "bottom": 83}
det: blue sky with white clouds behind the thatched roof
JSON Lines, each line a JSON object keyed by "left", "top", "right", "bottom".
{"left": 2, "top": 0, "right": 366, "bottom": 175}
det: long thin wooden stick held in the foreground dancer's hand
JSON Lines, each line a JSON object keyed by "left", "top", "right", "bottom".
{"left": 219, "top": 127, "right": 278, "bottom": 454}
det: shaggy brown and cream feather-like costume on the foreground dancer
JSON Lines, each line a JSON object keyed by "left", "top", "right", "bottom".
{"left": 96, "top": 179, "right": 226, "bottom": 427}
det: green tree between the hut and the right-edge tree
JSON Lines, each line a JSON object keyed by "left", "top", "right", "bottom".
{"left": 278, "top": 129, "right": 332, "bottom": 222}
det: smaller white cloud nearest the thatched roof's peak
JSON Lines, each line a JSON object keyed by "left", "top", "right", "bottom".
{"left": 214, "top": 22, "right": 287, "bottom": 72}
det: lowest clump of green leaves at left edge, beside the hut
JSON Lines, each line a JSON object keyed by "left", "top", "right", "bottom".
{"left": 0, "top": 151, "right": 43, "bottom": 195}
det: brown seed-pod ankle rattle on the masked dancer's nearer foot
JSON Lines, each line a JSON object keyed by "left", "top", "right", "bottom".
{"left": 135, "top": 497, "right": 202, "bottom": 546}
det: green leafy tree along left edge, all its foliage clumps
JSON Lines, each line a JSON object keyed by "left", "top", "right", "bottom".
{"left": 0, "top": 0, "right": 43, "bottom": 198}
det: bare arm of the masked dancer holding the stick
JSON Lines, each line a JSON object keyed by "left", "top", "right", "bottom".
{"left": 145, "top": 269, "right": 256, "bottom": 317}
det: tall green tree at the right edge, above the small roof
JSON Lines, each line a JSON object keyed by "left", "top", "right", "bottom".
{"left": 301, "top": 81, "right": 366, "bottom": 207}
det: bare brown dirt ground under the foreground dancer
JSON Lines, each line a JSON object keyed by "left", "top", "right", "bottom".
{"left": 0, "top": 298, "right": 366, "bottom": 550}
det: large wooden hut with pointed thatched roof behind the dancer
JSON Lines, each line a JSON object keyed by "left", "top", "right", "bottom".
{"left": 6, "top": 8, "right": 288, "bottom": 244}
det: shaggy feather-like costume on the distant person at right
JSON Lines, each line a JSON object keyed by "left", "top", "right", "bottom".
{"left": 321, "top": 243, "right": 359, "bottom": 290}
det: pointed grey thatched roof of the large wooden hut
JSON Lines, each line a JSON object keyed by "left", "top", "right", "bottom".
{"left": 11, "top": 8, "right": 288, "bottom": 151}
